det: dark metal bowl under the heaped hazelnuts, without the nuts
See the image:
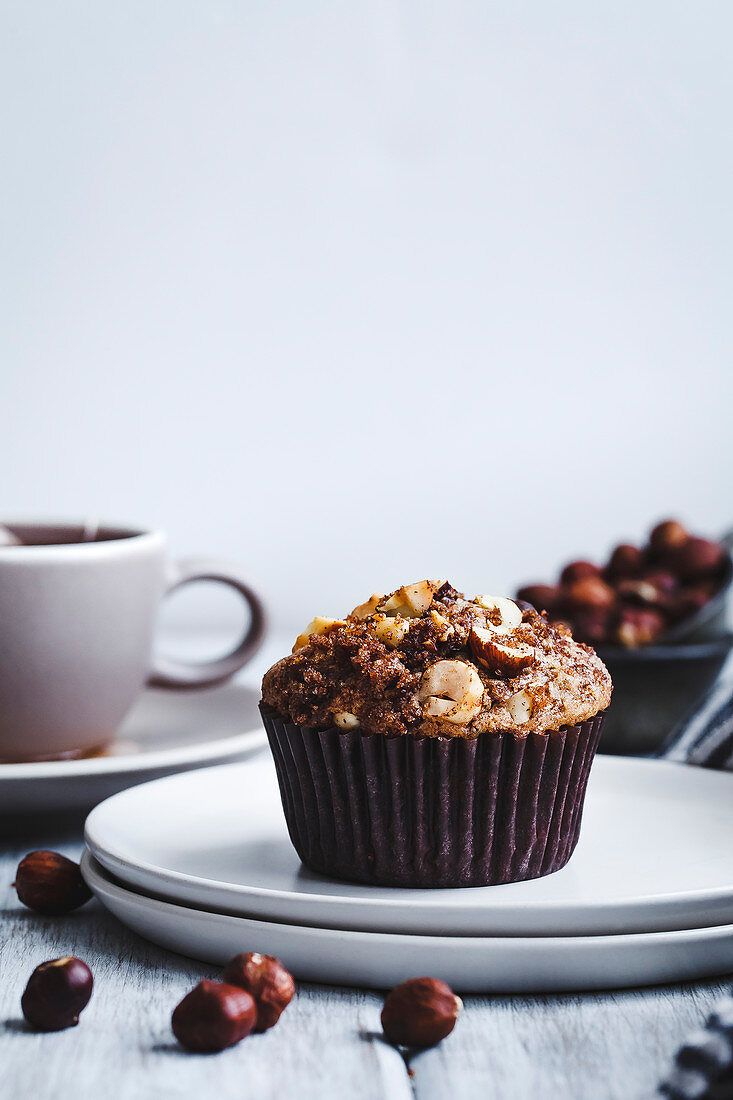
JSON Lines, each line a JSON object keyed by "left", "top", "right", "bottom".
{"left": 597, "top": 634, "right": 733, "bottom": 756}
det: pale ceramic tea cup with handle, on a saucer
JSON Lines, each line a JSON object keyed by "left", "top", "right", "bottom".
{"left": 0, "top": 523, "right": 264, "bottom": 761}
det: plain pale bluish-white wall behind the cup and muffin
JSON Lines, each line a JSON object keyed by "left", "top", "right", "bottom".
{"left": 0, "top": 0, "right": 733, "bottom": 627}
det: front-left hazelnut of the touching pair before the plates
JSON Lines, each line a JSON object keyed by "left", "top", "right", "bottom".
{"left": 171, "top": 981, "right": 258, "bottom": 1054}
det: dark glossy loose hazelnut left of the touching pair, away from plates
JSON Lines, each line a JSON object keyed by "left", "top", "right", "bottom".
{"left": 21, "top": 956, "right": 94, "bottom": 1031}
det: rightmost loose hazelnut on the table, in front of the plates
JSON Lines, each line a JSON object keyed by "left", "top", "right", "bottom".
{"left": 382, "top": 978, "right": 463, "bottom": 1046}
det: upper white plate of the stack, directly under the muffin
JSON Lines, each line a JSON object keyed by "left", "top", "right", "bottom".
{"left": 86, "top": 755, "right": 733, "bottom": 936}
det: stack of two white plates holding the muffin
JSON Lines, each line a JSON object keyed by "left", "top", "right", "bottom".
{"left": 84, "top": 756, "right": 733, "bottom": 992}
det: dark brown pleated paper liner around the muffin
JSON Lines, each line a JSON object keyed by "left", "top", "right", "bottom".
{"left": 260, "top": 704, "right": 603, "bottom": 887}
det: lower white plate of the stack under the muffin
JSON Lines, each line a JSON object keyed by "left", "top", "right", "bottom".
{"left": 81, "top": 851, "right": 733, "bottom": 993}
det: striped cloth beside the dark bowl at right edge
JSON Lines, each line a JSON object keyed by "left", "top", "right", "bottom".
{"left": 657, "top": 661, "right": 733, "bottom": 771}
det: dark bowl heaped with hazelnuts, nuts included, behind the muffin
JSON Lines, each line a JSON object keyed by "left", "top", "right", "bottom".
{"left": 516, "top": 519, "right": 733, "bottom": 754}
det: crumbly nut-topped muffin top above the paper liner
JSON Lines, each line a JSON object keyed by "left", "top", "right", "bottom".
{"left": 262, "top": 581, "right": 611, "bottom": 738}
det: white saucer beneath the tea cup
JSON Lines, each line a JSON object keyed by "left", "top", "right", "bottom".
{"left": 0, "top": 684, "right": 267, "bottom": 814}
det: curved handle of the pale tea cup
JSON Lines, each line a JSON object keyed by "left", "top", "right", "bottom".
{"left": 149, "top": 558, "right": 265, "bottom": 688}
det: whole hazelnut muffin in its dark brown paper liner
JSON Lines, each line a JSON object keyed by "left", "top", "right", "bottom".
{"left": 261, "top": 581, "right": 611, "bottom": 887}
